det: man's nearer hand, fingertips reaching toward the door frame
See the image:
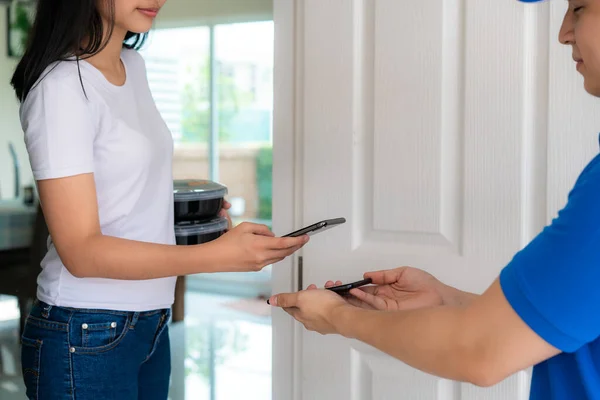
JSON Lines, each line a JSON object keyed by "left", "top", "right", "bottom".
{"left": 269, "top": 288, "right": 352, "bottom": 335}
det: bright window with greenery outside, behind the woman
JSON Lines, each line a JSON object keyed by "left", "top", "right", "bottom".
{"left": 141, "top": 21, "right": 273, "bottom": 225}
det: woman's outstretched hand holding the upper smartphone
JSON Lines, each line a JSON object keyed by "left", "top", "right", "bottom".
{"left": 209, "top": 222, "right": 308, "bottom": 272}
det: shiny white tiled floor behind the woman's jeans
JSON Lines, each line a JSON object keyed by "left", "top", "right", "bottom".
{"left": 0, "top": 292, "right": 271, "bottom": 400}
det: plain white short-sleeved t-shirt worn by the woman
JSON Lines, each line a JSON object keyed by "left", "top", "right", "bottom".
{"left": 20, "top": 50, "right": 176, "bottom": 311}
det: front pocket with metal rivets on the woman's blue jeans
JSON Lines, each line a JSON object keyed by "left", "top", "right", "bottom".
{"left": 70, "top": 313, "right": 129, "bottom": 352}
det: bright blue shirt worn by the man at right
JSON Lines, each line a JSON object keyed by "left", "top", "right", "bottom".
{"left": 500, "top": 138, "right": 600, "bottom": 400}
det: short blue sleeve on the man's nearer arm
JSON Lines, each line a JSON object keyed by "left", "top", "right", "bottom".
{"left": 500, "top": 160, "right": 600, "bottom": 352}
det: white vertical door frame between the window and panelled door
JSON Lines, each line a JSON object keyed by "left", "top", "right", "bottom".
{"left": 271, "top": 0, "right": 303, "bottom": 400}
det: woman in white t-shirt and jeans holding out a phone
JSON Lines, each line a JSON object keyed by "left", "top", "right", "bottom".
{"left": 12, "top": 0, "right": 308, "bottom": 399}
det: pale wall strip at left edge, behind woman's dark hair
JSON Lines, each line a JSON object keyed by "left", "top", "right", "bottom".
{"left": 0, "top": 6, "right": 32, "bottom": 198}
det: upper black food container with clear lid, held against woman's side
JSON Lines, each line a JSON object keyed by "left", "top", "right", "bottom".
{"left": 173, "top": 179, "right": 227, "bottom": 223}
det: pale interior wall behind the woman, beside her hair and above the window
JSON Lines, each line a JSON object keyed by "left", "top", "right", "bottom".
{"left": 0, "top": 0, "right": 273, "bottom": 198}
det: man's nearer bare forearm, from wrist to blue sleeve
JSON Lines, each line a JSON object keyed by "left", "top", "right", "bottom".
{"left": 331, "top": 280, "right": 560, "bottom": 386}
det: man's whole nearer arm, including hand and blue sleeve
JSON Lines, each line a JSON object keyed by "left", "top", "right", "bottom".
{"left": 271, "top": 158, "right": 600, "bottom": 386}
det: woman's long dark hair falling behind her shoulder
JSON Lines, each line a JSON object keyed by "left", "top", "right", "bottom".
{"left": 10, "top": 0, "right": 147, "bottom": 102}
